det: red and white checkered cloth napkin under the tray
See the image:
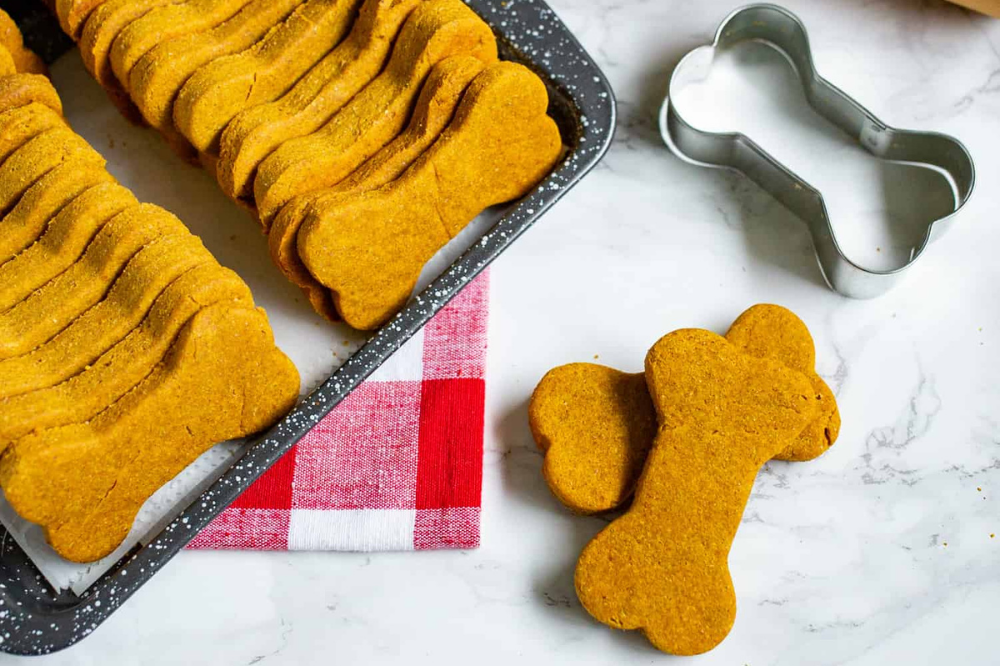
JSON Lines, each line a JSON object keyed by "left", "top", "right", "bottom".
{"left": 188, "top": 274, "right": 489, "bottom": 551}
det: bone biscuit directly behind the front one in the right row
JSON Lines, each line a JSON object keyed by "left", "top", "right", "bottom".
{"left": 267, "top": 56, "right": 485, "bottom": 321}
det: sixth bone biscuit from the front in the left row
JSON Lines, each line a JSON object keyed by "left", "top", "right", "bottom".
{"left": 0, "top": 161, "right": 114, "bottom": 262}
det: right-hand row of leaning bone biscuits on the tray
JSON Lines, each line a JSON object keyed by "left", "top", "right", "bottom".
{"left": 55, "top": 0, "right": 562, "bottom": 329}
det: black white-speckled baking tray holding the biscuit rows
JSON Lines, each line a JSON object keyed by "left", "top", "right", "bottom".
{"left": 0, "top": 0, "right": 616, "bottom": 655}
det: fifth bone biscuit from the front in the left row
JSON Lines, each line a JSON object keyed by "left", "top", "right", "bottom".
{"left": 0, "top": 183, "right": 139, "bottom": 312}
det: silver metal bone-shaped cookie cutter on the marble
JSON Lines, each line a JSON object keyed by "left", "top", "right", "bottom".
{"left": 660, "top": 4, "right": 976, "bottom": 298}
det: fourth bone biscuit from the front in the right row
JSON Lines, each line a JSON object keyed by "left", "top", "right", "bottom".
{"left": 216, "top": 0, "right": 421, "bottom": 201}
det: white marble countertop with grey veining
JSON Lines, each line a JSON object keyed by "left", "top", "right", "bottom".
{"left": 17, "top": 0, "right": 1000, "bottom": 666}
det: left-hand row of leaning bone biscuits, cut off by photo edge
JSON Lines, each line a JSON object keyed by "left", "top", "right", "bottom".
{"left": 0, "top": 12, "right": 299, "bottom": 562}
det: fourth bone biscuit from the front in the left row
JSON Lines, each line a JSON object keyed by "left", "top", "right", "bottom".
{"left": 0, "top": 204, "right": 188, "bottom": 359}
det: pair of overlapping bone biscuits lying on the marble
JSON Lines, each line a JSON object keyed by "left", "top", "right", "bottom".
{"left": 529, "top": 305, "right": 840, "bottom": 655}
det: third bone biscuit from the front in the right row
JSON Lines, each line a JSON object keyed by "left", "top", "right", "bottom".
{"left": 254, "top": 0, "right": 497, "bottom": 224}
